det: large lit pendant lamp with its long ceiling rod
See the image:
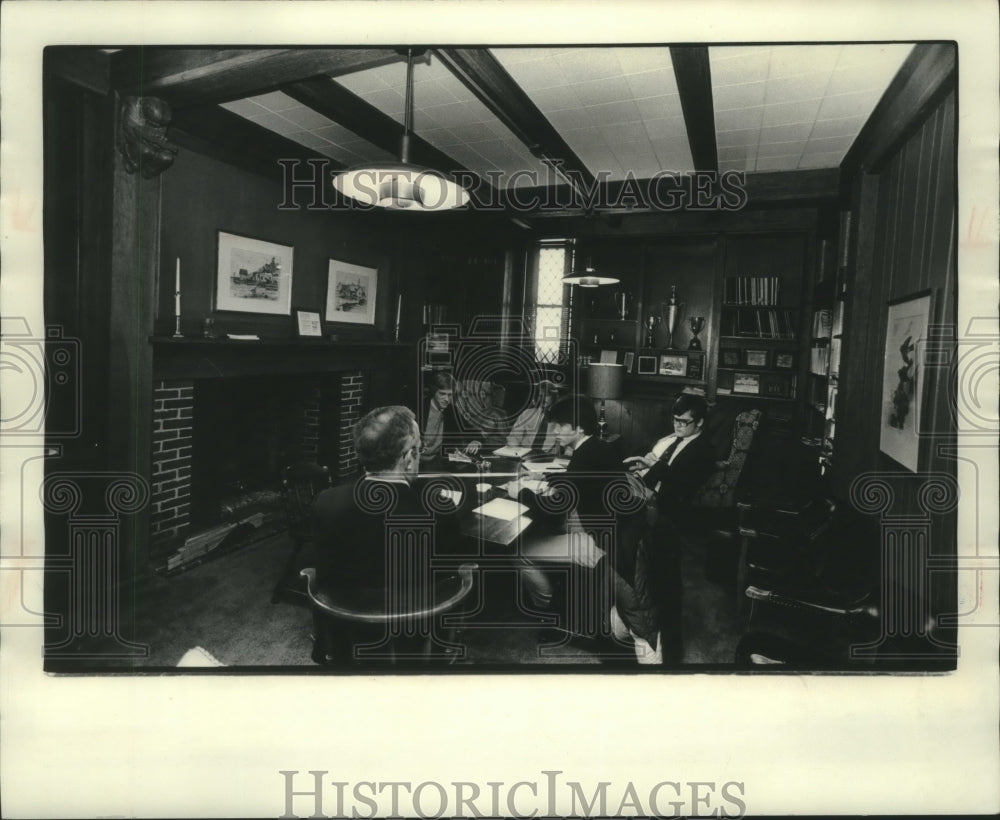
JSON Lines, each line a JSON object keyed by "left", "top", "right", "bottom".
{"left": 333, "top": 49, "right": 469, "bottom": 211}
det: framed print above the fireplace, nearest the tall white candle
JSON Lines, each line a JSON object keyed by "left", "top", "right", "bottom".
{"left": 215, "top": 231, "right": 294, "bottom": 316}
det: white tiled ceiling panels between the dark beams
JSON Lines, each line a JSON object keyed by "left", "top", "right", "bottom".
{"left": 224, "top": 44, "right": 913, "bottom": 191}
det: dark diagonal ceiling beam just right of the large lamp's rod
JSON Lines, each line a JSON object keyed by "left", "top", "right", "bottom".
{"left": 435, "top": 48, "right": 594, "bottom": 187}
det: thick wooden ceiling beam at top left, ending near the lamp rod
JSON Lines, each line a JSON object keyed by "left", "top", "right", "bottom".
{"left": 111, "top": 47, "right": 404, "bottom": 108}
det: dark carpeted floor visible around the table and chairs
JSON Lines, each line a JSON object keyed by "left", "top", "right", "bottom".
{"left": 68, "top": 535, "right": 739, "bottom": 669}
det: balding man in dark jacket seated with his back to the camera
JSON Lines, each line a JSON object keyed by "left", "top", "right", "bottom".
{"left": 313, "top": 406, "right": 461, "bottom": 624}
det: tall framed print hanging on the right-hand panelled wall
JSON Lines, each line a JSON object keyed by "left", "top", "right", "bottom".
{"left": 879, "top": 291, "right": 933, "bottom": 472}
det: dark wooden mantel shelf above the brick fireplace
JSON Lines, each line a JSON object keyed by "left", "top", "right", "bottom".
{"left": 149, "top": 336, "right": 416, "bottom": 379}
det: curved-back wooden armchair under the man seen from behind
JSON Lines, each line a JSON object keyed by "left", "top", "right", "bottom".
{"left": 301, "top": 564, "right": 478, "bottom": 665}
